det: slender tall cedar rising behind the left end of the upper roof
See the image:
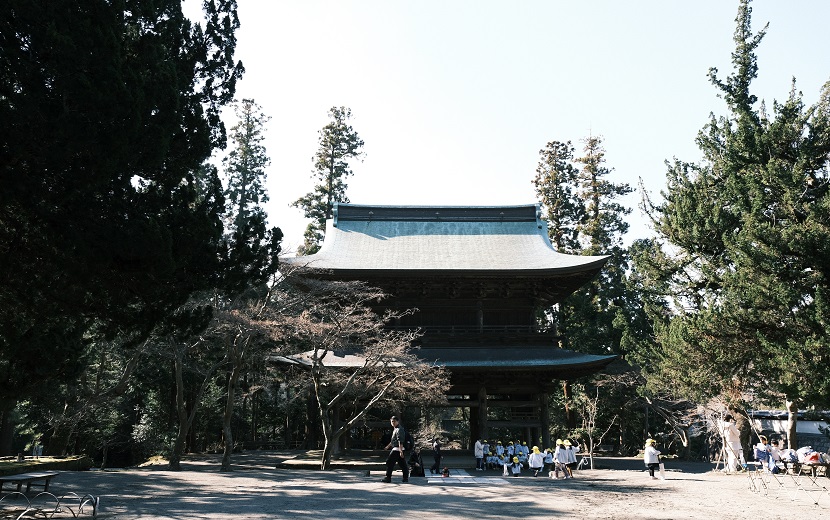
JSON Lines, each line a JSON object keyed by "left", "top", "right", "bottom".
{"left": 292, "top": 107, "right": 363, "bottom": 255}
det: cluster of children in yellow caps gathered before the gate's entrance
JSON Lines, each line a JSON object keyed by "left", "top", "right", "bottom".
{"left": 476, "top": 439, "right": 579, "bottom": 479}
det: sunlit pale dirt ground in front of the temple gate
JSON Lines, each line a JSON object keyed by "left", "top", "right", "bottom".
{"left": 8, "top": 453, "right": 830, "bottom": 520}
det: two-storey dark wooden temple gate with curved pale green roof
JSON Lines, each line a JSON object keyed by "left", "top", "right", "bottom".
{"left": 292, "top": 204, "right": 614, "bottom": 446}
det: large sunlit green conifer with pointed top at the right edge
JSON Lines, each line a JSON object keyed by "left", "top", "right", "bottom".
{"left": 638, "top": 0, "right": 830, "bottom": 446}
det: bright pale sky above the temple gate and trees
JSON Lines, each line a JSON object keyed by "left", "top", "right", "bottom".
{"left": 186, "top": 0, "right": 830, "bottom": 249}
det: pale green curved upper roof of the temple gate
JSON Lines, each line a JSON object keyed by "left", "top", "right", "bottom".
{"left": 285, "top": 204, "right": 608, "bottom": 276}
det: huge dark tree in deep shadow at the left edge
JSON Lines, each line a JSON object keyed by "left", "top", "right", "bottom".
{"left": 0, "top": 0, "right": 242, "bottom": 450}
